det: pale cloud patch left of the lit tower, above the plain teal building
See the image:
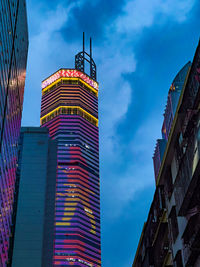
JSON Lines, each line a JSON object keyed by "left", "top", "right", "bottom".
{"left": 22, "top": 1, "right": 78, "bottom": 125}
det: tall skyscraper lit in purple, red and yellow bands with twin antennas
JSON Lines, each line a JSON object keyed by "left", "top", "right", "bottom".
{"left": 41, "top": 34, "right": 101, "bottom": 267}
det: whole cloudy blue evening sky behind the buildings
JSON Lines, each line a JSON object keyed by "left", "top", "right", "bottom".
{"left": 22, "top": 0, "right": 200, "bottom": 267}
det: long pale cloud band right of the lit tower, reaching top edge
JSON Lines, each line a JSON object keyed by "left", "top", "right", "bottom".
{"left": 99, "top": 0, "right": 195, "bottom": 222}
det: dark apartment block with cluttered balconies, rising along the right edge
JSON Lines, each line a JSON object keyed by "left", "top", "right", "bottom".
{"left": 133, "top": 40, "right": 200, "bottom": 267}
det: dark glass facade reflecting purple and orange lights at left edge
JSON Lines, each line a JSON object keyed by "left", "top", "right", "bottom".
{"left": 0, "top": 0, "right": 28, "bottom": 267}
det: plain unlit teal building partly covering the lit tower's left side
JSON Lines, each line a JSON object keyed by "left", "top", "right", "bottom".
{"left": 10, "top": 127, "right": 57, "bottom": 267}
